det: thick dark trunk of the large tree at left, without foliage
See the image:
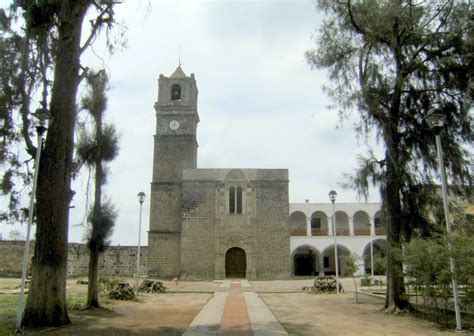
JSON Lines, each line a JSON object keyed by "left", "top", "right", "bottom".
{"left": 23, "top": 0, "right": 88, "bottom": 327}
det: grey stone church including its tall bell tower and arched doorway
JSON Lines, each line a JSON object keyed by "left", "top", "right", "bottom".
{"left": 148, "top": 67, "right": 291, "bottom": 280}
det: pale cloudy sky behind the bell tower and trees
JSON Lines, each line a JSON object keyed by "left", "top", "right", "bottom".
{"left": 0, "top": 0, "right": 379, "bottom": 245}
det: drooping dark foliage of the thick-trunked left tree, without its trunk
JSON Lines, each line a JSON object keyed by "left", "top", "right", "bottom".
{"left": 0, "top": 0, "right": 126, "bottom": 222}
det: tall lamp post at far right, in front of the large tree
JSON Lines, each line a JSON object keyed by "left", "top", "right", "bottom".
{"left": 425, "top": 110, "right": 462, "bottom": 331}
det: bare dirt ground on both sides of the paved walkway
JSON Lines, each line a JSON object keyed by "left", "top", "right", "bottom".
{"left": 0, "top": 279, "right": 474, "bottom": 336}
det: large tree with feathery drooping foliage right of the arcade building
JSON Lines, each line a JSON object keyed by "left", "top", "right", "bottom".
{"left": 306, "top": 0, "right": 474, "bottom": 310}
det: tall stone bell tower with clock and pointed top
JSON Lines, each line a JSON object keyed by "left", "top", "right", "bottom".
{"left": 148, "top": 66, "right": 199, "bottom": 277}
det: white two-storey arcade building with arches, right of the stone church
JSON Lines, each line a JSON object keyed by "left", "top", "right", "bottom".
{"left": 290, "top": 202, "right": 387, "bottom": 276}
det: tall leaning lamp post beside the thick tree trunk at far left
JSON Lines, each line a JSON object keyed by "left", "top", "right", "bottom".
{"left": 15, "top": 119, "right": 47, "bottom": 332}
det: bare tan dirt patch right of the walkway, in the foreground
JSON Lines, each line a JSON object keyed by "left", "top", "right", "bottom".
{"left": 260, "top": 293, "right": 460, "bottom": 336}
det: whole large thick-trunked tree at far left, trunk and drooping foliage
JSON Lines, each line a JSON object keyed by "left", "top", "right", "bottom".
{"left": 0, "top": 0, "right": 122, "bottom": 327}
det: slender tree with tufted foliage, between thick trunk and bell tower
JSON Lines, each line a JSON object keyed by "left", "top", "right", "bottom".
{"left": 77, "top": 70, "right": 119, "bottom": 308}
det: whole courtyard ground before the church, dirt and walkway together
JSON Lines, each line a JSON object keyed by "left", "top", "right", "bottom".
{"left": 0, "top": 278, "right": 468, "bottom": 336}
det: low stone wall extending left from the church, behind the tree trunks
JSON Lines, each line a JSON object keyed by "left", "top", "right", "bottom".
{"left": 0, "top": 241, "right": 148, "bottom": 277}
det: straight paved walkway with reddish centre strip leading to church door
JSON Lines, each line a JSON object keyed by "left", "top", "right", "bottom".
{"left": 183, "top": 280, "right": 288, "bottom": 336}
